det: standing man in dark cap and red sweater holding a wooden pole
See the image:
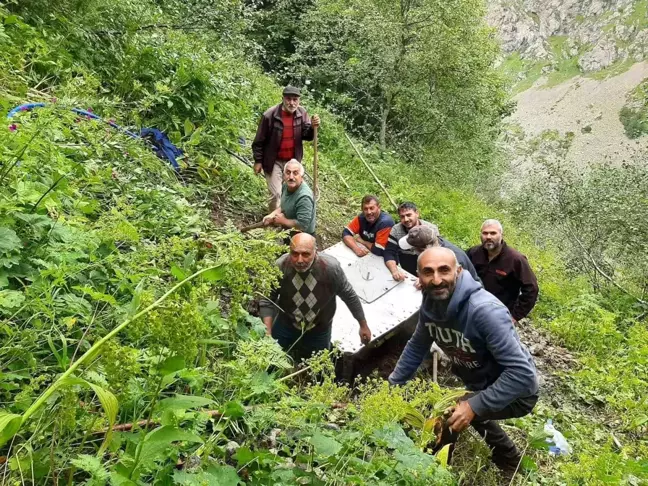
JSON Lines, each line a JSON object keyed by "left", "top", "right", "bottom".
{"left": 252, "top": 86, "right": 320, "bottom": 212}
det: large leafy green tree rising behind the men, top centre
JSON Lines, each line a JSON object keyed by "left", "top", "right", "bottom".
{"left": 291, "top": 0, "right": 506, "bottom": 158}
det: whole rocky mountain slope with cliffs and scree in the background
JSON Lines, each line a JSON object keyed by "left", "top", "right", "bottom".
{"left": 488, "top": 0, "right": 648, "bottom": 185}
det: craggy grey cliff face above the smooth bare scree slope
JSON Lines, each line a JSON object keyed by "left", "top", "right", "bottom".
{"left": 487, "top": 0, "right": 648, "bottom": 72}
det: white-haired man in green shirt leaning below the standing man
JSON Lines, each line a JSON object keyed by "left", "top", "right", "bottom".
{"left": 263, "top": 159, "right": 316, "bottom": 235}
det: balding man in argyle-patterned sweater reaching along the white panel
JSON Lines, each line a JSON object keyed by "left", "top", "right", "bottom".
{"left": 259, "top": 233, "right": 371, "bottom": 361}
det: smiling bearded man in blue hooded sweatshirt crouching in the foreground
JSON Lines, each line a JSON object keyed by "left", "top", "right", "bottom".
{"left": 389, "top": 248, "right": 538, "bottom": 477}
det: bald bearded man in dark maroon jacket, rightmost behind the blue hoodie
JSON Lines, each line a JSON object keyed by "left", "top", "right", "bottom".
{"left": 468, "top": 219, "right": 538, "bottom": 322}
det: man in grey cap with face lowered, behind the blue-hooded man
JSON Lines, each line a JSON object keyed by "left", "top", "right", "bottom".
{"left": 398, "top": 224, "right": 481, "bottom": 282}
